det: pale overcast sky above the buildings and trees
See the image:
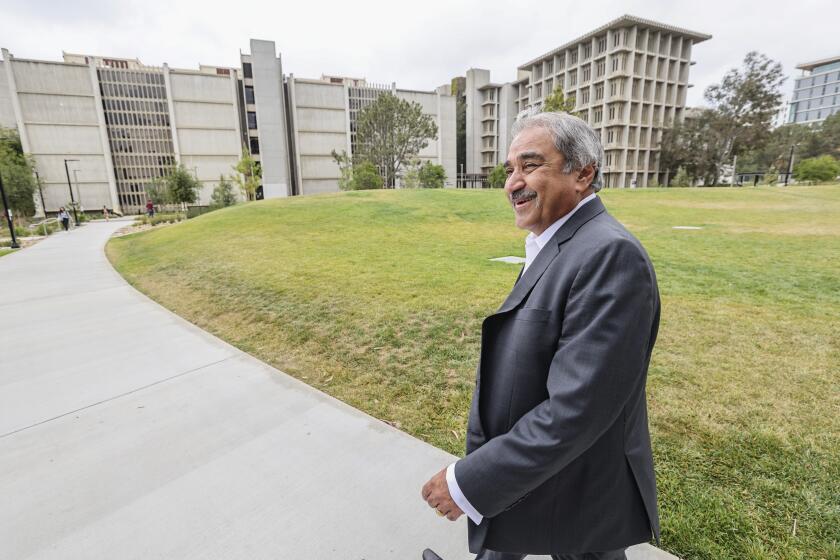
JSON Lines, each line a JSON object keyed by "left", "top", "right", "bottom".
{"left": 0, "top": 0, "right": 840, "bottom": 105}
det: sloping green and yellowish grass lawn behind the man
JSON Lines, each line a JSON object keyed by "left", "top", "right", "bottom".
{"left": 108, "top": 186, "right": 840, "bottom": 559}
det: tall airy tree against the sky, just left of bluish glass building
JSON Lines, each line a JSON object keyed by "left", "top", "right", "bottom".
{"left": 704, "top": 51, "right": 785, "bottom": 161}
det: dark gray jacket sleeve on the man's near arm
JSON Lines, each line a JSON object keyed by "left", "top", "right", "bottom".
{"left": 455, "top": 239, "right": 658, "bottom": 517}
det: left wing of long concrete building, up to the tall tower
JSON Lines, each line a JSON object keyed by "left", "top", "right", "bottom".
{"left": 0, "top": 49, "right": 241, "bottom": 213}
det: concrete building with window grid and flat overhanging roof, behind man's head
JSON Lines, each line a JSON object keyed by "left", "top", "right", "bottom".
{"left": 466, "top": 15, "right": 711, "bottom": 187}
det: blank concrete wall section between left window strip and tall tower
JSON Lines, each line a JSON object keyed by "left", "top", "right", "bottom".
{"left": 167, "top": 69, "right": 242, "bottom": 204}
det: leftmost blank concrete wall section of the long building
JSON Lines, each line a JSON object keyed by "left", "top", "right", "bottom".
{"left": 0, "top": 58, "right": 114, "bottom": 212}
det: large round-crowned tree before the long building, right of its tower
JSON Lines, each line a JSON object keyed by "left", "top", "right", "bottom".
{"left": 353, "top": 93, "right": 438, "bottom": 188}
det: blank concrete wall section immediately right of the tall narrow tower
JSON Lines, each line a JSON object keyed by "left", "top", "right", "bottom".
{"left": 289, "top": 77, "right": 349, "bottom": 194}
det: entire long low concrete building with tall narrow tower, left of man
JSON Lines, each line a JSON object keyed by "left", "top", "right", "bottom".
{"left": 0, "top": 40, "right": 456, "bottom": 213}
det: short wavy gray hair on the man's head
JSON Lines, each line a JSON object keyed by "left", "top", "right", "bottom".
{"left": 511, "top": 110, "right": 604, "bottom": 192}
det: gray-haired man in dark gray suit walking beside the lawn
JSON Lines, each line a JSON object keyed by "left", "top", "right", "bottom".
{"left": 422, "top": 113, "right": 659, "bottom": 560}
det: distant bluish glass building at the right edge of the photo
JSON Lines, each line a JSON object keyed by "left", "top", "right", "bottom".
{"left": 788, "top": 56, "right": 840, "bottom": 124}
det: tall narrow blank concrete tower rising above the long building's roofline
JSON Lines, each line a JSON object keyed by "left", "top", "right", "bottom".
{"left": 251, "top": 39, "right": 291, "bottom": 198}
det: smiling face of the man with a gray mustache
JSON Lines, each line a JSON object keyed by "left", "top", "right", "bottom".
{"left": 505, "top": 127, "right": 595, "bottom": 235}
